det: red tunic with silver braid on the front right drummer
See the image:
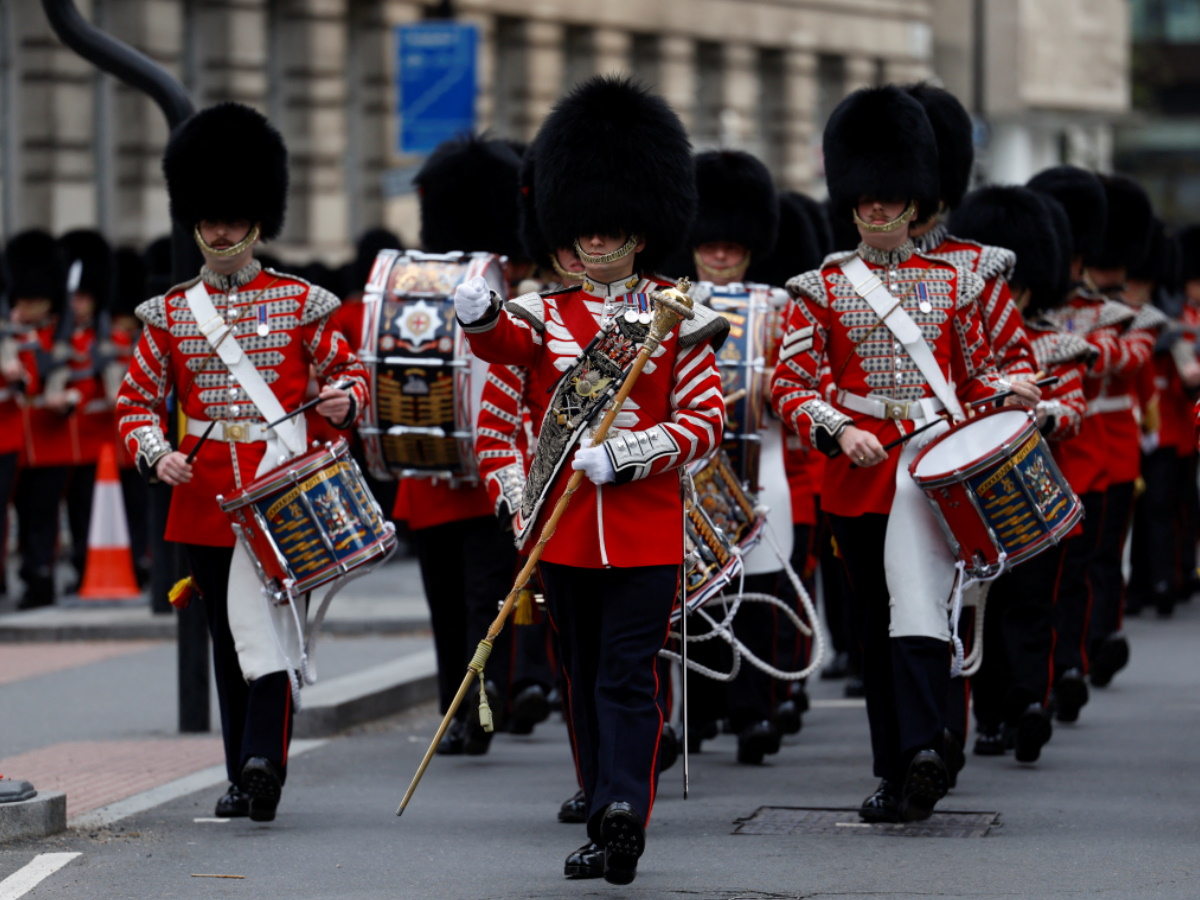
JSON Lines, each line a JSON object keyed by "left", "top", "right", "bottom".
{"left": 772, "top": 242, "right": 998, "bottom": 516}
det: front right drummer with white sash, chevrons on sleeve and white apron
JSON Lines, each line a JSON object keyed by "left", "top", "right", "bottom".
{"left": 772, "top": 86, "right": 1039, "bottom": 822}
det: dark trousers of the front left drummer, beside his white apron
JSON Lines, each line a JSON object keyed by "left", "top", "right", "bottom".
{"left": 182, "top": 544, "right": 295, "bottom": 784}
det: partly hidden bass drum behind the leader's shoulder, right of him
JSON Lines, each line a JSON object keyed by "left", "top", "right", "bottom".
{"left": 709, "top": 284, "right": 773, "bottom": 488}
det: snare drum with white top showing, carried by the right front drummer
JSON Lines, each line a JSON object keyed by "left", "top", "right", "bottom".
{"left": 908, "top": 408, "right": 1084, "bottom": 577}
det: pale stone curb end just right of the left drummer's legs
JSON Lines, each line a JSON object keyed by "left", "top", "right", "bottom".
{"left": 295, "top": 648, "right": 438, "bottom": 738}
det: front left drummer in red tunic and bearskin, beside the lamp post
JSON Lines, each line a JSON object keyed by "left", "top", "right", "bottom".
{"left": 116, "top": 103, "right": 367, "bottom": 822}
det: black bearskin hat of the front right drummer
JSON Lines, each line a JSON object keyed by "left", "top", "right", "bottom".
{"left": 824, "top": 84, "right": 941, "bottom": 226}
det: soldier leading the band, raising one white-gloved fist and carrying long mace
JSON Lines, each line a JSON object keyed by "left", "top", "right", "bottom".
{"left": 455, "top": 77, "right": 728, "bottom": 884}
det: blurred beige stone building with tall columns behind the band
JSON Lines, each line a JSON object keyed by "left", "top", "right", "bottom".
{"left": 0, "top": 0, "right": 1124, "bottom": 263}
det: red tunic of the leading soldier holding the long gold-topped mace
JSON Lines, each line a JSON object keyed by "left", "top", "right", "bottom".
{"left": 466, "top": 276, "right": 727, "bottom": 569}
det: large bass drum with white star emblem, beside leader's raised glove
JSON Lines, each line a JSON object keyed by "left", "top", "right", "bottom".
{"left": 358, "top": 250, "right": 508, "bottom": 480}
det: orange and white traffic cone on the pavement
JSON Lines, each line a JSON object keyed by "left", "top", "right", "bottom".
{"left": 79, "top": 444, "right": 142, "bottom": 600}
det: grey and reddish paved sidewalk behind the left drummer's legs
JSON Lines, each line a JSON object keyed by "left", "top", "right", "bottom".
{"left": 0, "top": 559, "right": 436, "bottom": 840}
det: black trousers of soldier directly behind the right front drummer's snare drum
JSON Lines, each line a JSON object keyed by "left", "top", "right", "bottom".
{"left": 971, "top": 544, "right": 1067, "bottom": 732}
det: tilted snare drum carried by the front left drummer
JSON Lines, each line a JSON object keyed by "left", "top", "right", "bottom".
{"left": 217, "top": 439, "right": 396, "bottom": 594}
